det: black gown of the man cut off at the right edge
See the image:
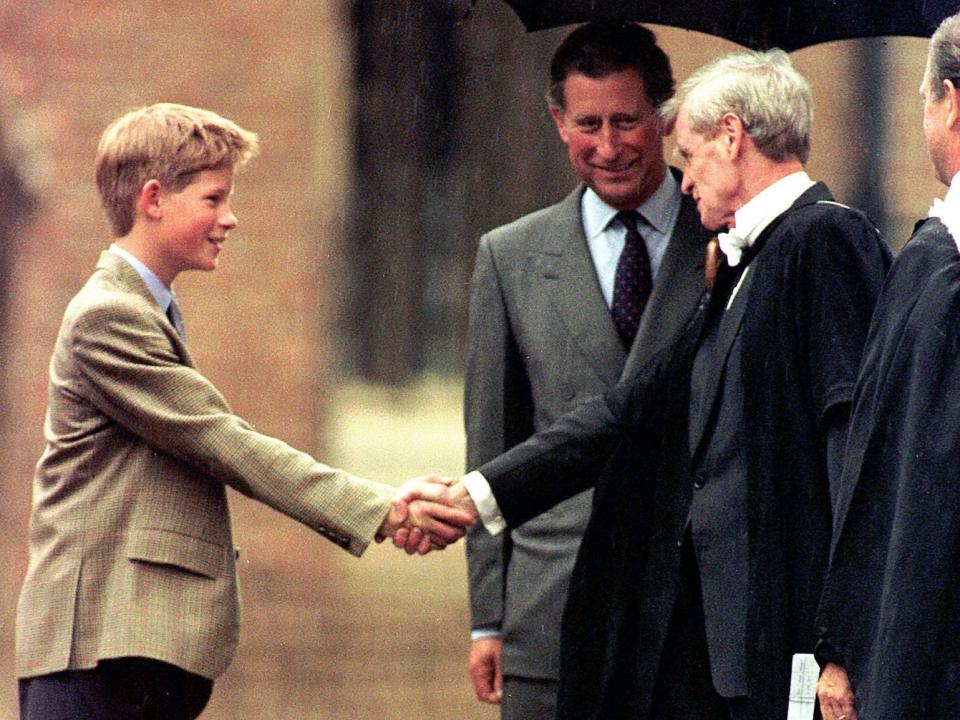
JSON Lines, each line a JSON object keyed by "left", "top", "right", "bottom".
{"left": 818, "top": 220, "right": 960, "bottom": 720}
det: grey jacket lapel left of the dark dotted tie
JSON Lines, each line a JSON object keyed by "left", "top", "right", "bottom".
{"left": 540, "top": 186, "right": 626, "bottom": 385}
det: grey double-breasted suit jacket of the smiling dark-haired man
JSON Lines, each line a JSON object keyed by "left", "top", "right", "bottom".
{"left": 465, "top": 177, "right": 707, "bottom": 679}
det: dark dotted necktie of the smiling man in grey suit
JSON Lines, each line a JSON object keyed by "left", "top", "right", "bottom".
{"left": 610, "top": 210, "right": 653, "bottom": 349}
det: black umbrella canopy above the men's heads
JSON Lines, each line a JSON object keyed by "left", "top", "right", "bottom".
{"left": 498, "top": 0, "right": 960, "bottom": 51}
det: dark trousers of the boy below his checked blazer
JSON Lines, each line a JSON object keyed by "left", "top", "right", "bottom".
{"left": 20, "top": 657, "right": 213, "bottom": 720}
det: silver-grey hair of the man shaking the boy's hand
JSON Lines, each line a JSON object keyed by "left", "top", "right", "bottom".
{"left": 660, "top": 49, "right": 813, "bottom": 162}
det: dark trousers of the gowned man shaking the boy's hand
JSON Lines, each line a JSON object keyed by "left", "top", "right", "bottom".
{"left": 649, "top": 529, "right": 747, "bottom": 720}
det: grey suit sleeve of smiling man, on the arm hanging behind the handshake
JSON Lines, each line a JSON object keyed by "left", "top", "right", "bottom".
{"left": 464, "top": 236, "right": 533, "bottom": 630}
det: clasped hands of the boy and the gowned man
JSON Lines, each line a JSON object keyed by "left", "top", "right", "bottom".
{"left": 376, "top": 475, "right": 477, "bottom": 555}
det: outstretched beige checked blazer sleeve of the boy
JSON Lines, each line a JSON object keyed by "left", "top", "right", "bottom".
{"left": 69, "top": 299, "right": 393, "bottom": 555}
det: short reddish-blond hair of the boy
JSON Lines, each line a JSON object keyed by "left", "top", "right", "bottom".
{"left": 96, "top": 103, "right": 259, "bottom": 237}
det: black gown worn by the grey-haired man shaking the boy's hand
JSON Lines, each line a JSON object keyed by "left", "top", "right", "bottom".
{"left": 480, "top": 184, "right": 889, "bottom": 720}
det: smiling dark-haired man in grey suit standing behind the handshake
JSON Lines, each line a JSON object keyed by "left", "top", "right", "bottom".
{"left": 465, "top": 23, "right": 706, "bottom": 720}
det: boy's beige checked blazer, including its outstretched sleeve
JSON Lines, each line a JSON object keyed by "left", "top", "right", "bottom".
{"left": 16, "top": 252, "right": 393, "bottom": 678}
